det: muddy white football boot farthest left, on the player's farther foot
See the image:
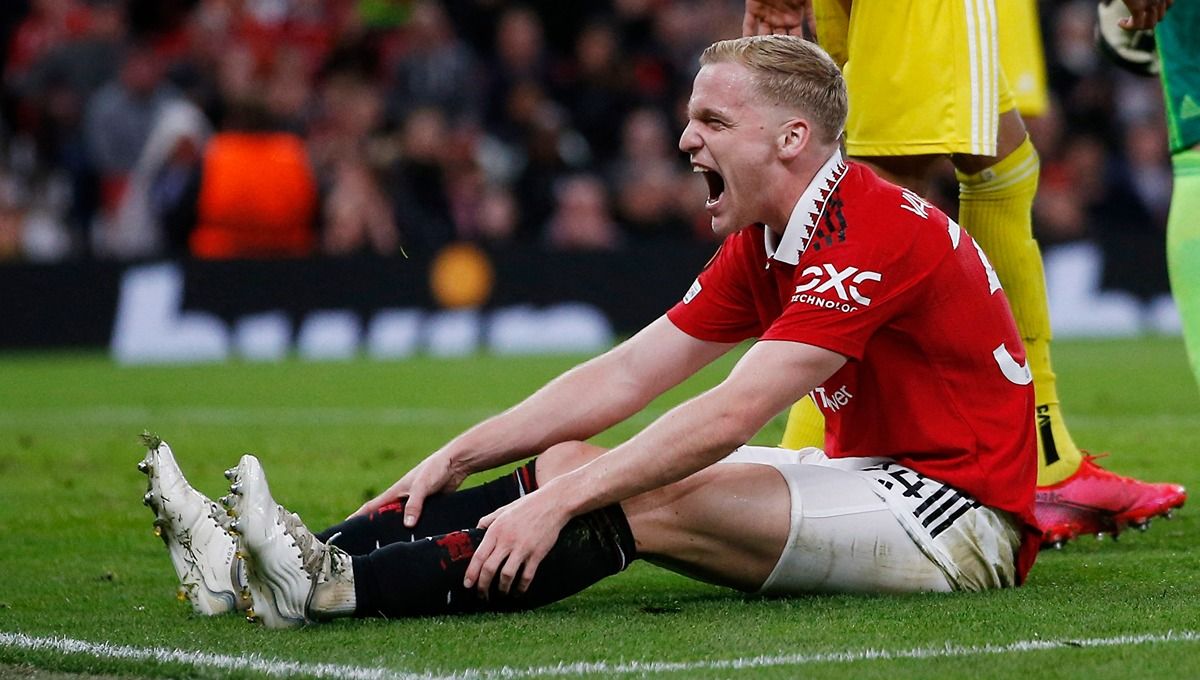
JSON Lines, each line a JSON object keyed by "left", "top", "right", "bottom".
{"left": 138, "top": 433, "right": 250, "bottom": 616}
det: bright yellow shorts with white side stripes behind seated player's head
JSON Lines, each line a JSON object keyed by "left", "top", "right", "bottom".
{"left": 814, "top": 0, "right": 1044, "bottom": 156}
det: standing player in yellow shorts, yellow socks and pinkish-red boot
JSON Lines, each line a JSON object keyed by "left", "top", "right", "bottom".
{"left": 743, "top": 0, "right": 1195, "bottom": 547}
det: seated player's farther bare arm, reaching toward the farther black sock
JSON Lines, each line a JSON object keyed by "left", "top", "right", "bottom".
{"left": 355, "top": 317, "right": 733, "bottom": 518}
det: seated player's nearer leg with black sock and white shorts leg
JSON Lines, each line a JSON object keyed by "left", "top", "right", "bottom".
{"left": 352, "top": 443, "right": 953, "bottom": 616}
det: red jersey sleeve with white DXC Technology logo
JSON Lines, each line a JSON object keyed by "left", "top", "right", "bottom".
{"left": 761, "top": 194, "right": 949, "bottom": 360}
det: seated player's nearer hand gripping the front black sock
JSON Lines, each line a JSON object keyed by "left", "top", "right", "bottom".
{"left": 463, "top": 491, "right": 571, "bottom": 598}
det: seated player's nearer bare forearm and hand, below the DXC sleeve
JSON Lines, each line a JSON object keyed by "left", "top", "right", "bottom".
{"left": 467, "top": 341, "right": 846, "bottom": 592}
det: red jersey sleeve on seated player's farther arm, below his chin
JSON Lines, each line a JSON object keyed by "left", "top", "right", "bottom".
{"left": 667, "top": 228, "right": 763, "bottom": 342}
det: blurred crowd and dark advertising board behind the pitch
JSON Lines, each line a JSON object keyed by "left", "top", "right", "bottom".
{"left": 0, "top": 0, "right": 1178, "bottom": 362}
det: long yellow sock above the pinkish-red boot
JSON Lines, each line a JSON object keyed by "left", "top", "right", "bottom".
{"left": 958, "top": 138, "right": 1082, "bottom": 486}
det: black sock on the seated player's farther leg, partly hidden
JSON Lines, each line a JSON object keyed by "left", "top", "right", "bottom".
{"left": 317, "top": 459, "right": 538, "bottom": 555}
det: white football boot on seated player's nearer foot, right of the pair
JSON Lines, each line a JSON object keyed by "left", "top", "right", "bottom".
{"left": 221, "top": 453, "right": 355, "bottom": 628}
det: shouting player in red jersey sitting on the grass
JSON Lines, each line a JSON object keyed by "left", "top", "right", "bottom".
{"left": 142, "top": 36, "right": 1039, "bottom": 627}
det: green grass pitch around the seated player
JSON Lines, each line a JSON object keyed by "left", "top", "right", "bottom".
{"left": 0, "top": 339, "right": 1200, "bottom": 679}
